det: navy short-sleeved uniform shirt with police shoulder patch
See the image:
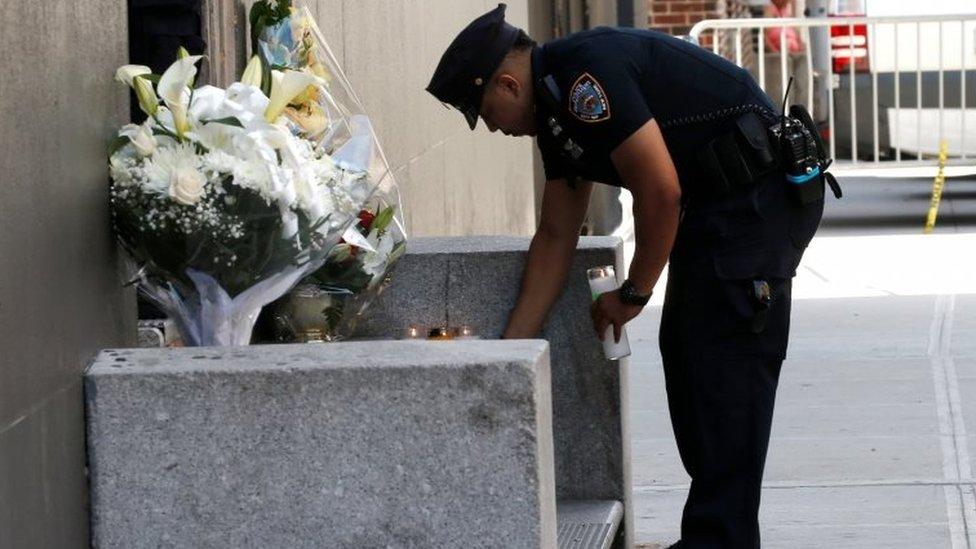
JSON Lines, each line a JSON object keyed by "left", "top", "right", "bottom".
{"left": 532, "top": 27, "right": 775, "bottom": 189}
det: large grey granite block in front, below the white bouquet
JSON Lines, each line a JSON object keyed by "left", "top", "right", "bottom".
{"left": 86, "top": 340, "right": 556, "bottom": 549}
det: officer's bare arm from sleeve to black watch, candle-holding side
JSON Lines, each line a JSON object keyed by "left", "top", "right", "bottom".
{"left": 610, "top": 120, "right": 681, "bottom": 295}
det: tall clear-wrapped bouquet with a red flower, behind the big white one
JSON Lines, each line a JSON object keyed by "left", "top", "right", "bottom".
{"left": 250, "top": 0, "right": 406, "bottom": 341}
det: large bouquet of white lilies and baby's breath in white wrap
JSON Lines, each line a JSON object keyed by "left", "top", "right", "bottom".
{"left": 109, "top": 38, "right": 395, "bottom": 345}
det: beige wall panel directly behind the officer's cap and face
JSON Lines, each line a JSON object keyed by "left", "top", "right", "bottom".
{"left": 307, "top": 0, "right": 535, "bottom": 236}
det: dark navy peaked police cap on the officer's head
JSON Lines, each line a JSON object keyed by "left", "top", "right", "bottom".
{"left": 427, "top": 4, "right": 522, "bottom": 130}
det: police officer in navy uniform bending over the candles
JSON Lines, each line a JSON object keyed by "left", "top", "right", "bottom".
{"left": 427, "top": 4, "right": 825, "bottom": 548}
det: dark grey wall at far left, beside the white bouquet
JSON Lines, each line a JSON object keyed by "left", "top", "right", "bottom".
{"left": 0, "top": 0, "right": 135, "bottom": 548}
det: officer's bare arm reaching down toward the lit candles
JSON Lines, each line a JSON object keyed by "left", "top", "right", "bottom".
{"left": 502, "top": 180, "right": 593, "bottom": 339}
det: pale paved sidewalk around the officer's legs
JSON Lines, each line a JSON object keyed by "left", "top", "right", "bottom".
{"left": 628, "top": 173, "right": 976, "bottom": 549}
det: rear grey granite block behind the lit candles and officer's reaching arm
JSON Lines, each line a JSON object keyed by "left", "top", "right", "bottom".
{"left": 357, "top": 233, "right": 634, "bottom": 547}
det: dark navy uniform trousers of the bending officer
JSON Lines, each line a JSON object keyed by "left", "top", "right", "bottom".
{"left": 660, "top": 169, "right": 823, "bottom": 549}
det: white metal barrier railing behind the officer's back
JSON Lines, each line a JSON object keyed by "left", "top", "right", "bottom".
{"left": 689, "top": 14, "right": 976, "bottom": 166}
